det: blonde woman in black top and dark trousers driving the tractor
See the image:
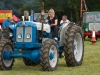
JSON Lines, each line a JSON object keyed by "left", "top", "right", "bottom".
{"left": 46, "top": 9, "right": 58, "bottom": 40}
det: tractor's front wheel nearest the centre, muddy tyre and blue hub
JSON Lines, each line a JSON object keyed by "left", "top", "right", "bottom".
{"left": 40, "top": 39, "right": 58, "bottom": 71}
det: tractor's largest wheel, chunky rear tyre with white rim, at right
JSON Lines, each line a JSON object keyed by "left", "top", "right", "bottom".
{"left": 64, "top": 25, "right": 84, "bottom": 67}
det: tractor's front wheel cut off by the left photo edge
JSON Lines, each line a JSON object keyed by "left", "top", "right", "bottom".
{"left": 0, "top": 39, "right": 14, "bottom": 70}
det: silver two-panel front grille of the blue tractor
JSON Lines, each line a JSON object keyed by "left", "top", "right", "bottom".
{"left": 16, "top": 26, "right": 32, "bottom": 42}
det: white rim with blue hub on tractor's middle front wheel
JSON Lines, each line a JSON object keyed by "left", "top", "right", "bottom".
{"left": 49, "top": 45, "right": 58, "bottom": 68}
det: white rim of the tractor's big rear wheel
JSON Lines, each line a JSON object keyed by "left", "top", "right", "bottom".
{"left": 74, "top": 33, "right": 83, "bottom": 62}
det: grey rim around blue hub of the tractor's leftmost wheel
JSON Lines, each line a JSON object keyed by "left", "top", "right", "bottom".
{"left": 3, "top": 45, "right": 13, "bottom": 67}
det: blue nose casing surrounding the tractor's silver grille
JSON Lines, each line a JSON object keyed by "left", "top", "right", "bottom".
{"left": 14, "top": 21, "right": 37, "bottom": 48}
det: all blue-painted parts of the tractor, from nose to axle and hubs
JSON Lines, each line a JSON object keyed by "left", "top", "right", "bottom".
{"left": 3, "top": 19, "right": 64, "bottom": 63}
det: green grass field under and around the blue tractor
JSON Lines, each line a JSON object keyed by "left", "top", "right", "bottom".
{"left": 0, "top": 40, "right": 100, "bottom": 75}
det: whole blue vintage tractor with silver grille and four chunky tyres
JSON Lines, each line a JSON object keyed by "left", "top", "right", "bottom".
{"left": 0, "top": 21, "right": 84, "bottom": 71}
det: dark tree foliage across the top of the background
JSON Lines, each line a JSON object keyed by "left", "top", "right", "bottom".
{"left": 0, "top": 0, "right": 100, "bottom": 21}
